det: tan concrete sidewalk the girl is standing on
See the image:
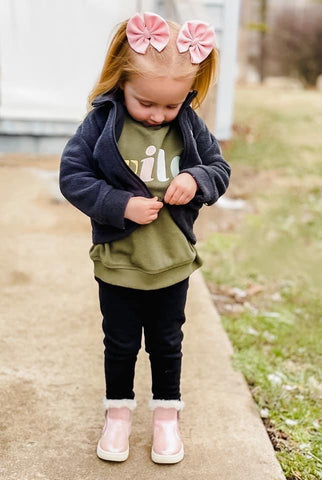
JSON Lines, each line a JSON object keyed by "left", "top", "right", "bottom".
{"left": 0, "top": 159, "right": 284, "bottom": 480}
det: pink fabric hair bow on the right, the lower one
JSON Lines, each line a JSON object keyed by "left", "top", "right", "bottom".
{"left": 177, "top": 20, "right": 215, "bottom": 63}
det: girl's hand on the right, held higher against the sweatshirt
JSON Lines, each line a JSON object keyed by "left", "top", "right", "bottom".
{"left": 164, "top": 173, "right": 198, "bottom": 205}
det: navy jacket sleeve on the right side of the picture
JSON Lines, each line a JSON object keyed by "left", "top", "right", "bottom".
{"left": 180, "top": 111, "right": 230, "bottom": 205}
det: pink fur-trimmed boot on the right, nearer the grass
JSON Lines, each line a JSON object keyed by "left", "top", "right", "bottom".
{"left": 150, "top": 400, "right": 184, "bottom": 463}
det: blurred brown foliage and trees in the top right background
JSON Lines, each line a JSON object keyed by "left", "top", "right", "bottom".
{"left": 241, "top": 0, "right": 322, "bottom": 87}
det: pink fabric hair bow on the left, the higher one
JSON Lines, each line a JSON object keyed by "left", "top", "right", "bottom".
{"left": 126, "top": 12, "right": 170, "bottom": 54}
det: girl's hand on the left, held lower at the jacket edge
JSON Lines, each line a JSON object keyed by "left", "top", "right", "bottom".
{"left": 124, "top": 197, "right": 163, "bottom": 225}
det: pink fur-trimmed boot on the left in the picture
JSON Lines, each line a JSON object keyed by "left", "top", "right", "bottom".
{"left": 96, "top": 399, "right": 136, "bottom": 462}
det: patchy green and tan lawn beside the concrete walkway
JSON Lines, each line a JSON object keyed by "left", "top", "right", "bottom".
{"left": 200, "top": 87, "right": 322, "bottom": 480}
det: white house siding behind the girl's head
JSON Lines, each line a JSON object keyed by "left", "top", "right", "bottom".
{"left": 0, "top": 0, "right": 239, "bottom": 153}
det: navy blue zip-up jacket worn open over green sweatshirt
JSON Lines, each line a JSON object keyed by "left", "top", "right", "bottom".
{"left": 59, "top": 90, "right": 230, "bottom": 244}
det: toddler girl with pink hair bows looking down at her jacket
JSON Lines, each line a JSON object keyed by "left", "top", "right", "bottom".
{"left": 60, "top": 13, "right": 230, "bottom": 463}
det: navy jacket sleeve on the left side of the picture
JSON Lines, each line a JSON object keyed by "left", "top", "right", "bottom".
{"left": 59, "top": 109, "right": 133, "bottom": 229}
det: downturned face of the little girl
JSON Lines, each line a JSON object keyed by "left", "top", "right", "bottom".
{"left": 122, "top": 75, "right": 193, "bottom": 127}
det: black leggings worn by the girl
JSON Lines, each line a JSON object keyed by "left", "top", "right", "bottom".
{"left": 96, "top": 278, "right": 189, "bottom": 400}
